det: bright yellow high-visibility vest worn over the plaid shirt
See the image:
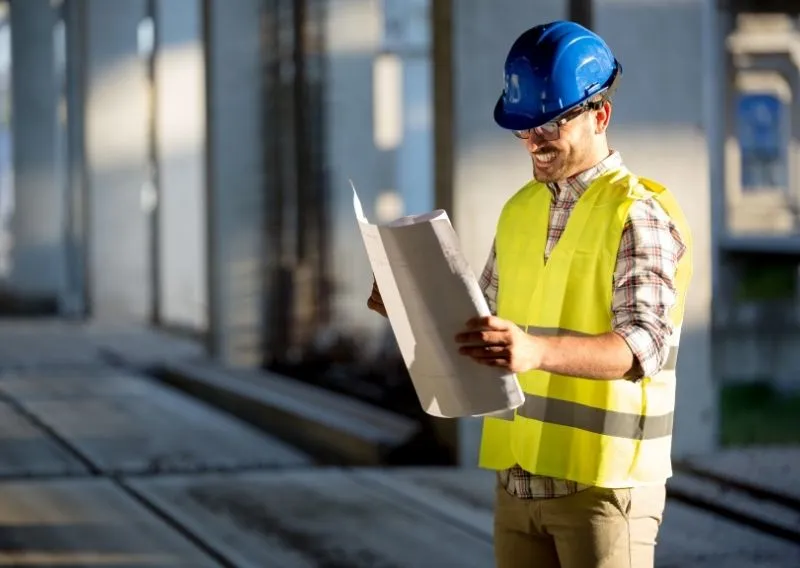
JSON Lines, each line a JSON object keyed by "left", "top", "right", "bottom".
{"left": 479, "top": 168, "right": 692, "bottom": 488}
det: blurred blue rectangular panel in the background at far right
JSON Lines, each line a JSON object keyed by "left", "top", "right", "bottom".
{"left": 737, "top": 93, "right": 785, "bottom": 158}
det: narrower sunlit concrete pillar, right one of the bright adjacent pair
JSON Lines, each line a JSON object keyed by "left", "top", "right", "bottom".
{"left": 154, "top": 0, "right": 207, "bottom": 331}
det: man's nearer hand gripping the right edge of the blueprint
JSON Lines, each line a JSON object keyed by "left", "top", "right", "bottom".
{"left": 456, "top": 316, "right": 543, "bottom": 373}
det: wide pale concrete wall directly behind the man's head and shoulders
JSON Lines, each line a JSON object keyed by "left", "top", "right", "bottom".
{"left": 453, "top": 0, "right": 716, "bottom": 465}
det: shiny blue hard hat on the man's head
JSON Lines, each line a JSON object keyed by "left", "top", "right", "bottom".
{"left": 494, "top": 21, "right": 622, "bottom": 130}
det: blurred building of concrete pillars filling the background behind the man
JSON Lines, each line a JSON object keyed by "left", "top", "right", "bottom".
{"left": 0, "top": 0, "right": 800, "bottom": 464}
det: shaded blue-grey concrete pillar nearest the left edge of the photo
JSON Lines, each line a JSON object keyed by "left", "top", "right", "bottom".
{"left": 10, "top": 0, "right": 66, "bottom": 300}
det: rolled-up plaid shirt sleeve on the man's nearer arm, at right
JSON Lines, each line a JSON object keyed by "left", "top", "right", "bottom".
{"left": 611, "top": 199, "right": 686, "bottom": 379}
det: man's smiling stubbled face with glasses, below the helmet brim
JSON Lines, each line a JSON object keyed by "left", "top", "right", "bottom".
{"left": 522, "top": 105, "right": 610, "bottom": 183}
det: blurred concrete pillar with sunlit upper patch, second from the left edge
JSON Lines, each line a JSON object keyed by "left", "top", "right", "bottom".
{"left": 85, "top": 0, "right": 154, "bottom": 323}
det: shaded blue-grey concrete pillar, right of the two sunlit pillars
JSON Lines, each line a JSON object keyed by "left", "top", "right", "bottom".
{"left": 204, "top": 0, "right": 268, "bottom": 365}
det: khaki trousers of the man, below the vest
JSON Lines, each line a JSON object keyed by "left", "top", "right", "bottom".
{"left": 494, "top": 483, "right": 666, "bottom": 568}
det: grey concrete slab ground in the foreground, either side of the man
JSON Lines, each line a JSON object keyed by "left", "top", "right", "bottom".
{"left": 0, "top": 323, "right": 800, "bottom": 568}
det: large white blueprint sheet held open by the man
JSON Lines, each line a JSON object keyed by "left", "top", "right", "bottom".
{"left": 353, "top": 187, "right": 524, "bottom": 418}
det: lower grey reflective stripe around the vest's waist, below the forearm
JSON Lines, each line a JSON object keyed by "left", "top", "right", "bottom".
{"left": 496, "top": 394, "right": 673, "bottom": 440}
